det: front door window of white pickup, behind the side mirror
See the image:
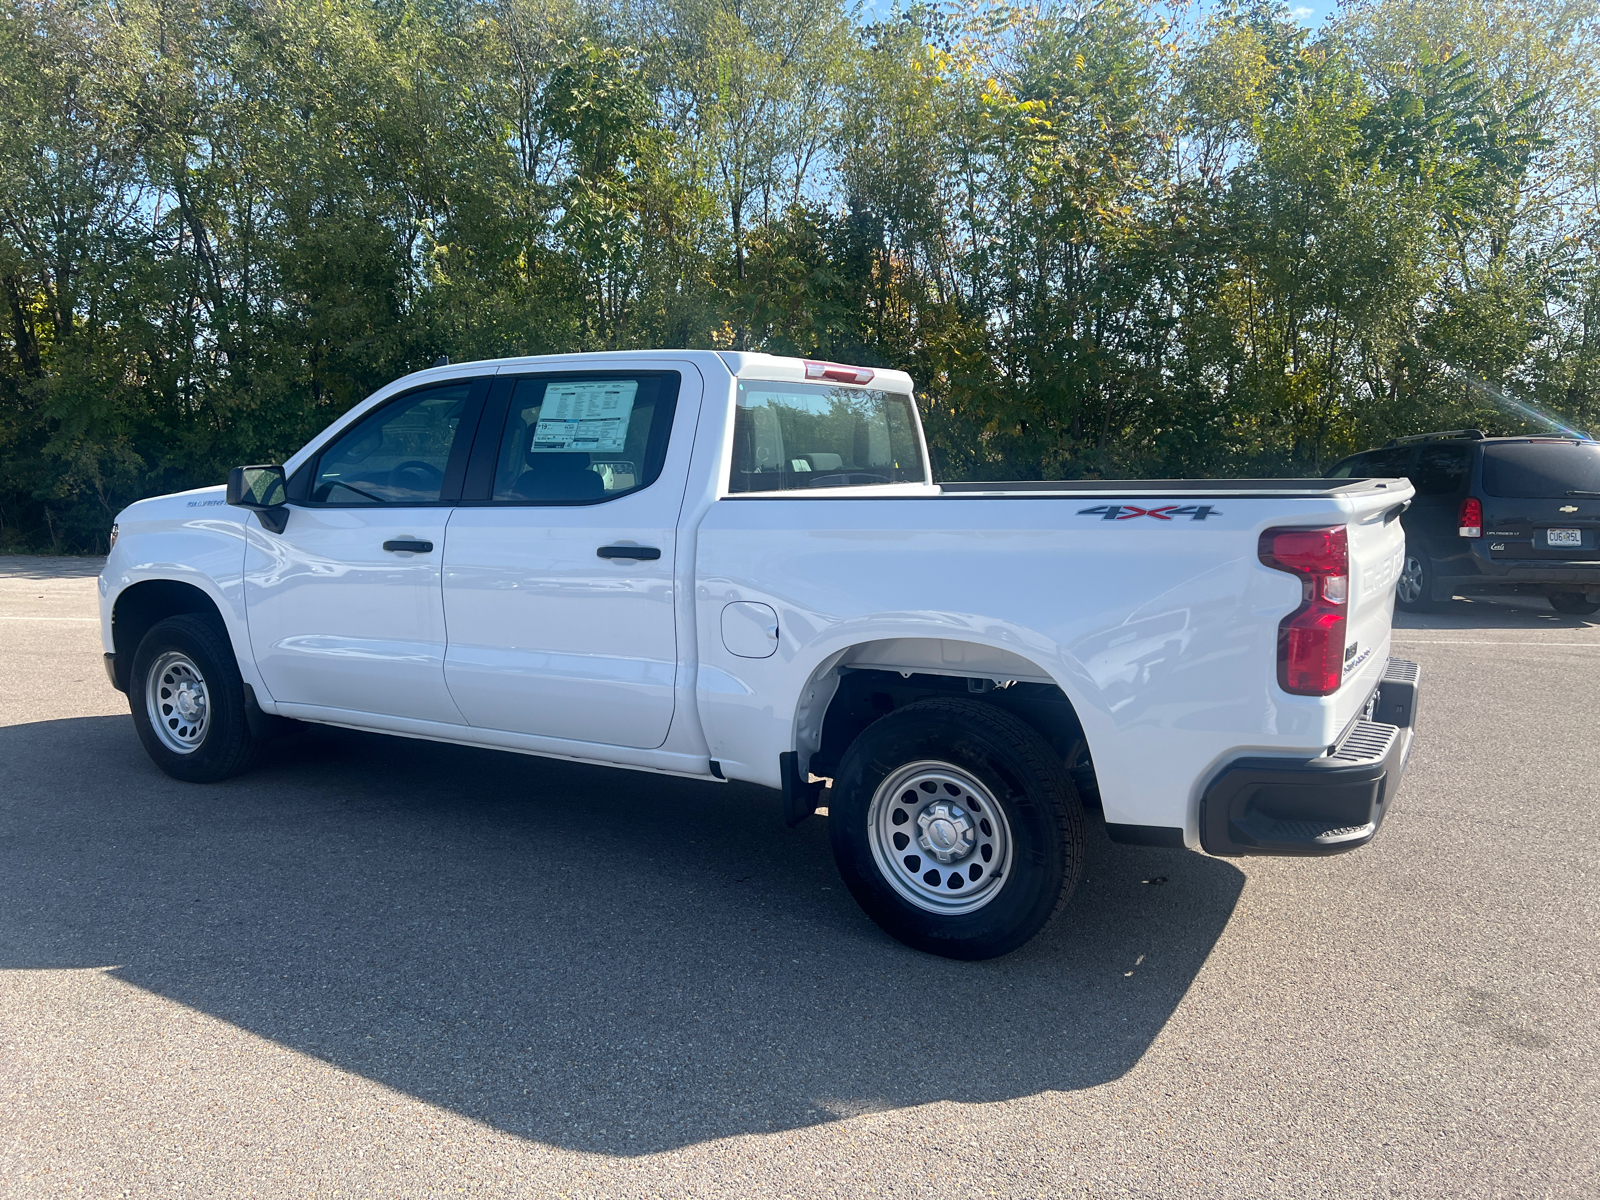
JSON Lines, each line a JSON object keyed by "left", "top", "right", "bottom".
{"left": 310, "top": 381, "right": 472, "bottom": 504}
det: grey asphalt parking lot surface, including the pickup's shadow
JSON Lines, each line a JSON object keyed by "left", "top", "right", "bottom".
{"left": 0, "top": 558, "right": 1600, "bottom": 1197}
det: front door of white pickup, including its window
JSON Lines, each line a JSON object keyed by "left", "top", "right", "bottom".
{"left": 245, "top": 379, "right": 488, "bottom": 725}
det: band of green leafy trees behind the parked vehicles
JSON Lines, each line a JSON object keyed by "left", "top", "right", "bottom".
{"left": 0, "top": 0, "right": 1600, "bottom": 550}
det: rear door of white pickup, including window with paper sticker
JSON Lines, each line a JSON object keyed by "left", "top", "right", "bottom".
{"left": 445, "top": 368, "right": 701, "bottom": 749}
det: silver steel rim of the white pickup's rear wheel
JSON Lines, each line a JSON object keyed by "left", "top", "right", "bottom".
{"left": 867, "top": 760, "right": 1011, "bottom": 917}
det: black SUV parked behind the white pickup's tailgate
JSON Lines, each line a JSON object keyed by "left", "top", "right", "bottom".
{"left": 1328, "top": 429, "right": 1600, "bottom": 614}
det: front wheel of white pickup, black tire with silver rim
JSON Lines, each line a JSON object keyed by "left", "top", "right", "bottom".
{"left": 128, "top": 613, "right": 259, "bottom": 784}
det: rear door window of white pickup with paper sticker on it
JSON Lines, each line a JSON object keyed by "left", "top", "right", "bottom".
{"left": 493, "top": 373, "right": 678, "bottom": 504}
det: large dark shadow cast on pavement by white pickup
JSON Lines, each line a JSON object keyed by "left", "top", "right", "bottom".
{"left": 0, "top": 717, "right": 1243, "bottom": 1155}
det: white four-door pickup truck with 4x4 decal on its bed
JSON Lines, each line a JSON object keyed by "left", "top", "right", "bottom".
{"left": 101, "top": 350, "right": 1418, "bottom": 958}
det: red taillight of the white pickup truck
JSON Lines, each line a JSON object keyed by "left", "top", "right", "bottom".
{"left": 1259, "top": 525, "right": 1350, "bottom": 696}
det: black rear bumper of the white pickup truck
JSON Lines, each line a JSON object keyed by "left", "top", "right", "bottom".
{"left": 1200, "top": 658, "right": 1419, "bottom": 858}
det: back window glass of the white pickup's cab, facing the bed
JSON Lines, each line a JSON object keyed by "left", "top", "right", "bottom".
{"left": 728, "top": 379, "right": 926, "bottom": 493}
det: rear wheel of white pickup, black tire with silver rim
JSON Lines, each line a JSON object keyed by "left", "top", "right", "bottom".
{"left": 827, "top": 698, "right": 1085, "bottom": 958}
